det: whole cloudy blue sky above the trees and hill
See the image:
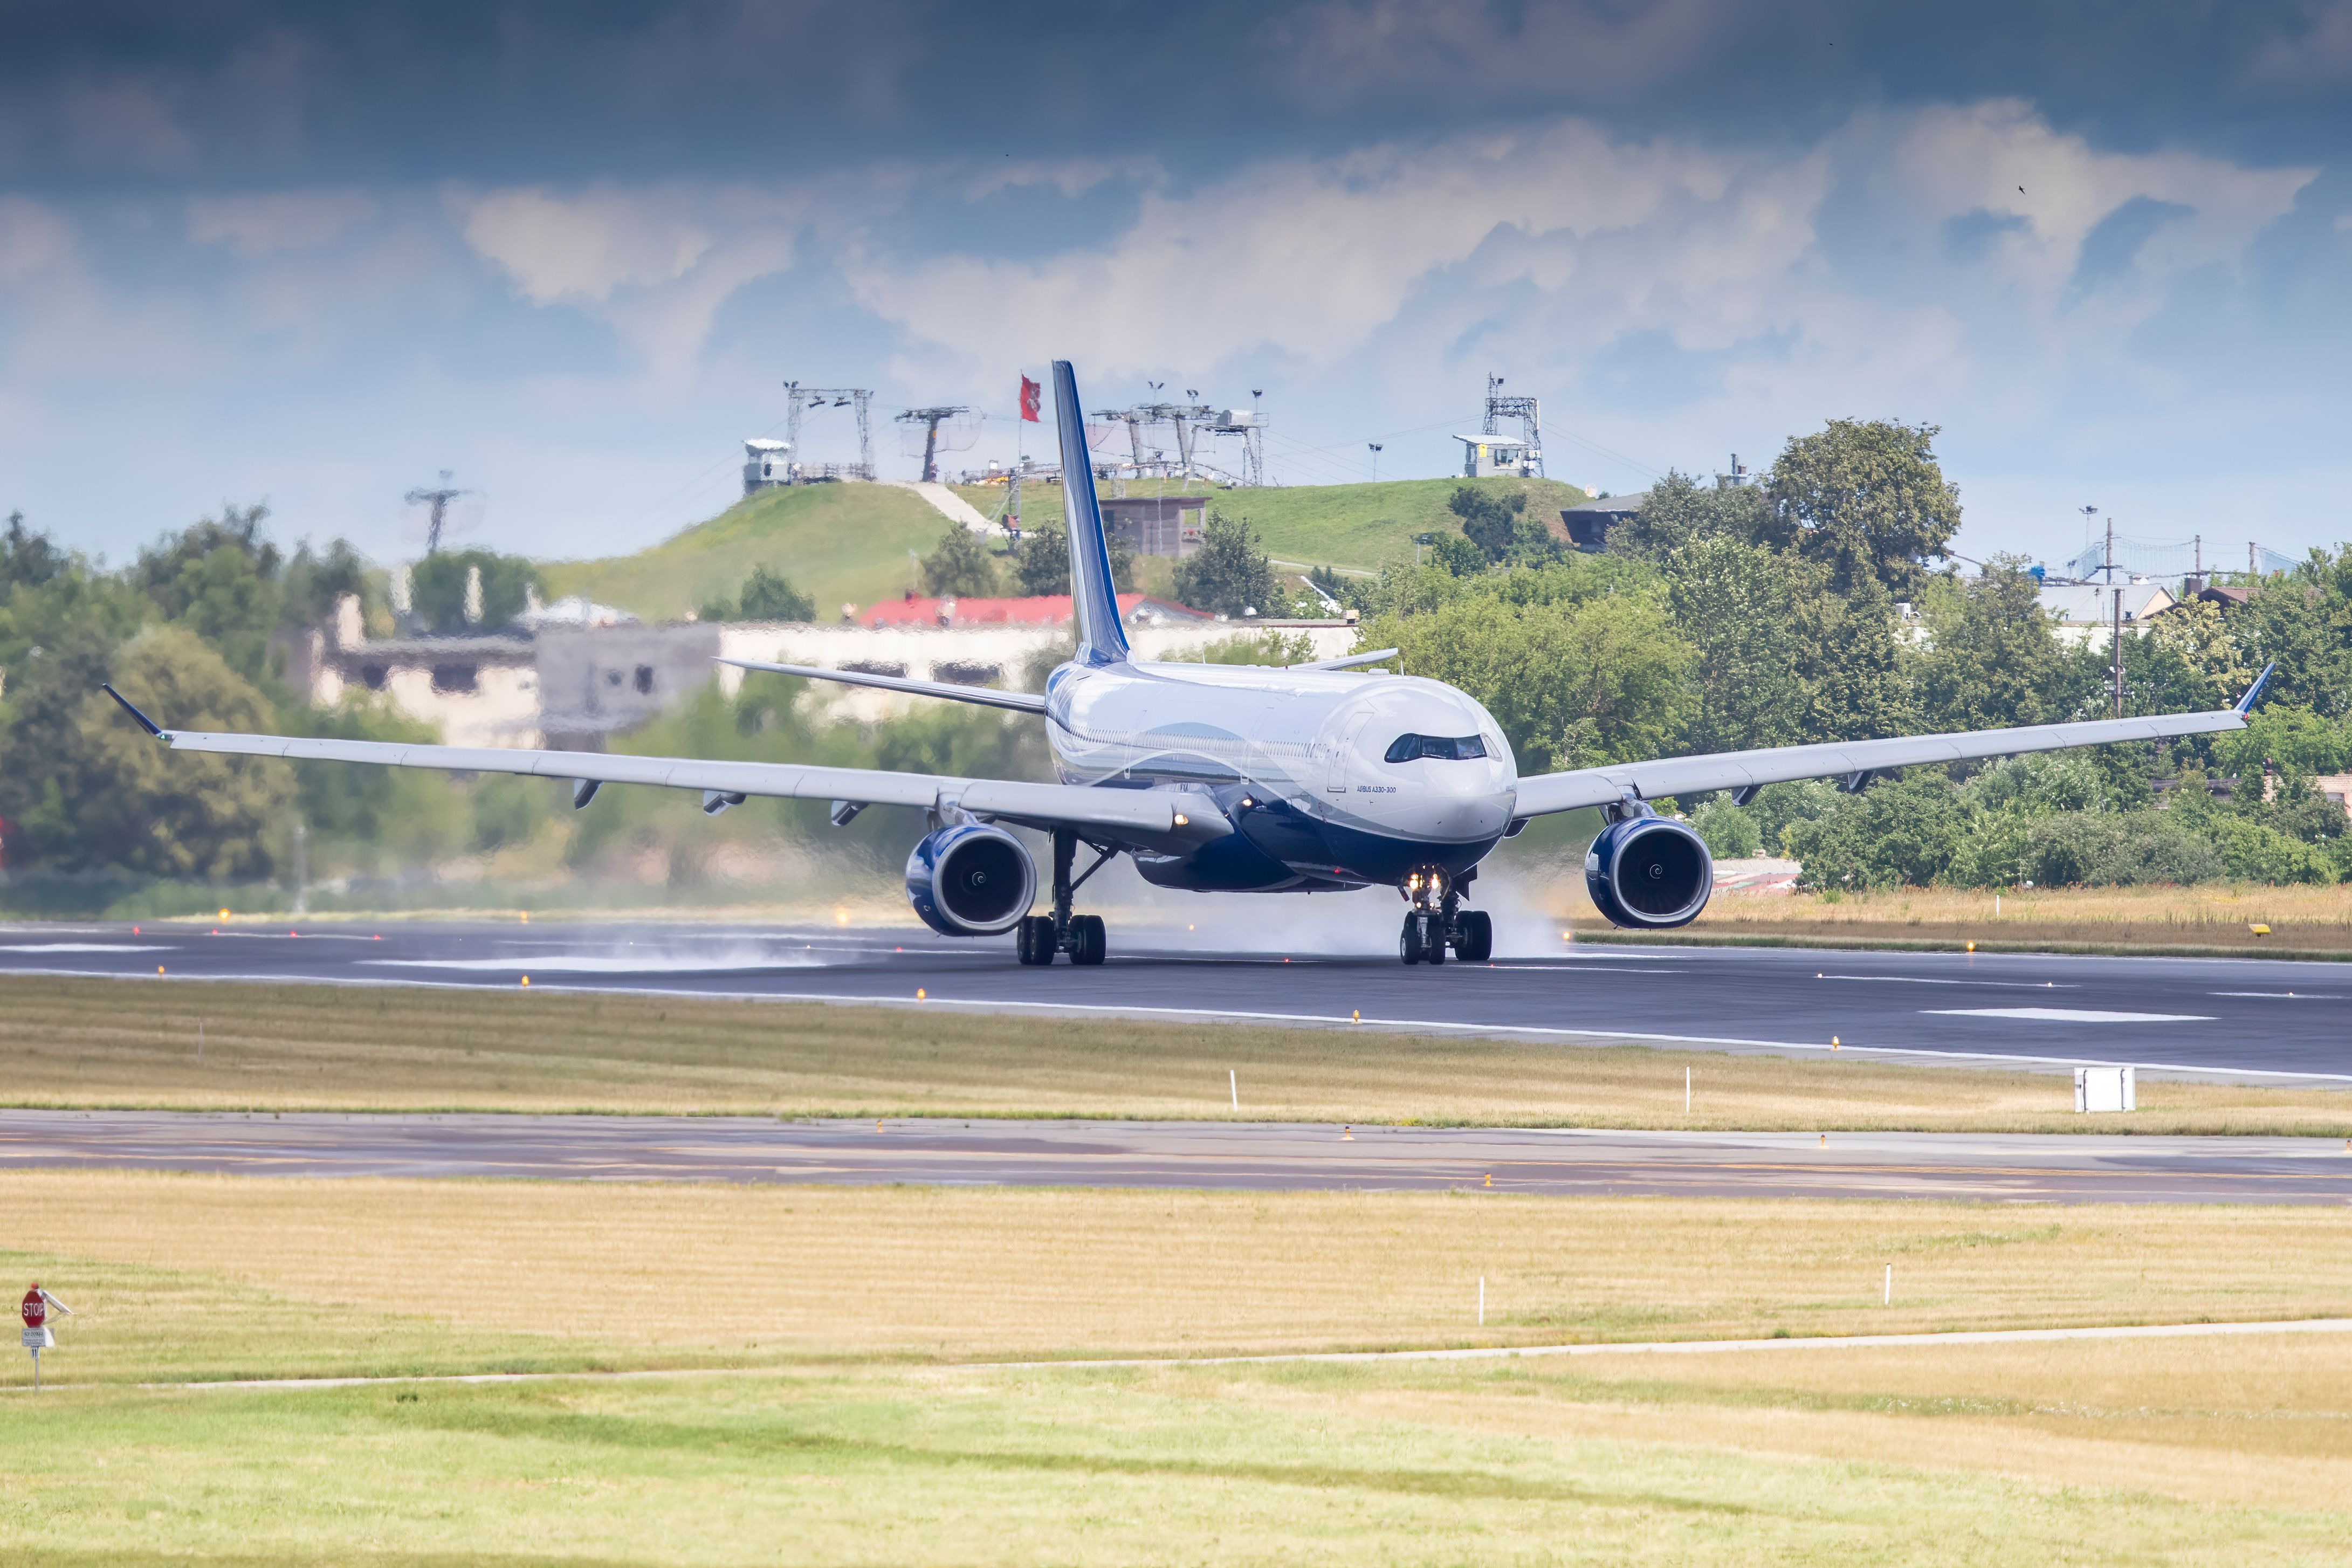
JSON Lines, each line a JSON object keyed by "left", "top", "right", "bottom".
{"left": 0, "top": 0, "right": 2352, "bottom": 564}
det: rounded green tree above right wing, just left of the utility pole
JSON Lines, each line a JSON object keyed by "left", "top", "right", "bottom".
{"left": 1919, "top": 555, "right": 2067, "bottom": 729}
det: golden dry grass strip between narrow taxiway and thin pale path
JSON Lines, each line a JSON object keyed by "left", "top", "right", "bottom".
{"left": 0, "top": 1171, "right": 2352, "bottom": 1380}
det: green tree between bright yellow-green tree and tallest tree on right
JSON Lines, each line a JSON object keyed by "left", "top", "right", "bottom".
{"left": 1665, "top": 534, "right": 1804, "bottom": 752}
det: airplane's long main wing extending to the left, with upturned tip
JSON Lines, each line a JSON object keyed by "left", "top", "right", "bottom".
{"left": 106, "top": 686, "right": 1233, "bottom": 854}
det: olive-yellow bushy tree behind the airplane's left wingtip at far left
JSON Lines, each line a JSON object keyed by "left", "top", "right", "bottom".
{"left": 17, "top": 625, "right": 294, "bottom": 882}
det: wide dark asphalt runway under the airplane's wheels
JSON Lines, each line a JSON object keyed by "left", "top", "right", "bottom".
{"left": 0, "top": 910, "right": 2352, "bottom": 1084}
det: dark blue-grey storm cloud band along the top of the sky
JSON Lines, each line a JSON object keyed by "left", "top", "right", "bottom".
{"left": 0, "top": 0, "right": 2352, "bottom": 185}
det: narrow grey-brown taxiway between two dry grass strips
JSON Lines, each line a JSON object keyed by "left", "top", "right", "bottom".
{"left": 0, "top": 1110, "right": 2352, "bottom": 1203}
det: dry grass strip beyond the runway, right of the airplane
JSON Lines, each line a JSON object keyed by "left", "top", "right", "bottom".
{"left": 1655, "top": 884, "right": 2352, "bottom": 959}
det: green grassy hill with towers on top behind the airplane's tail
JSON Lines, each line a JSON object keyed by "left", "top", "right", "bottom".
{"left": 546, "top": 479, "right": 1585, "bottom": 621}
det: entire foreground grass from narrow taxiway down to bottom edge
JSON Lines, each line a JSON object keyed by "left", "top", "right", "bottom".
{"left": 0, "top": 1173, "right": 2352, "bottom": 1568}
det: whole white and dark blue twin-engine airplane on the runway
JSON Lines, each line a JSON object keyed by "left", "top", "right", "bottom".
{"left": 106, "top": 362, "right": 2270, "bottom": 964}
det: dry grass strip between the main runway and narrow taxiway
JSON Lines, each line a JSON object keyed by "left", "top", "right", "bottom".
{"left": 0, "top": 975, "right": 2352, "bottom": 1138}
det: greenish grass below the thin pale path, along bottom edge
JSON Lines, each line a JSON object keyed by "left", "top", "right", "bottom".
{"left": 0, "top": 1347, "right": 2352, "bottom": 1568}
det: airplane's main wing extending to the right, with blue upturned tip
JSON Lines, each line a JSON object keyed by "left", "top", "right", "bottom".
{"left": 1515, "top": 668, "right": 2270, "bottom": 818}
